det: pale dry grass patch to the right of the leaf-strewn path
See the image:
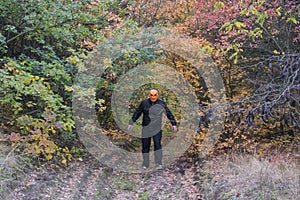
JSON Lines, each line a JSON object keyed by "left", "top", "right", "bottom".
{"left": 199, "top": 155, "right": 300, "bottom": 200}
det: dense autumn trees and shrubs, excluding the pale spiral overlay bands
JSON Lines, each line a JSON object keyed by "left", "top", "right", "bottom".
{"left": 0, "top": 0, "right": 300, "bottom": 164}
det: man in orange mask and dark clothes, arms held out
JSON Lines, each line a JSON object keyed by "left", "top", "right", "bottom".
{"left": 128, "top": 89, "right": 177, "bottom": 169}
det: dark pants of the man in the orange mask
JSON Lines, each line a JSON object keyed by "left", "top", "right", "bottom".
{"left": 142, "top": 130, "right": 162, "bottom": 167}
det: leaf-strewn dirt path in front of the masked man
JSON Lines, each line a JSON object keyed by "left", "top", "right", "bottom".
{"left": 8, "top": 156, "right": 199, "bottom": 200}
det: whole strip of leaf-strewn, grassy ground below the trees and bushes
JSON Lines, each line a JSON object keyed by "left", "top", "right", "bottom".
{"left": 0, "top": 143, "right": 300, "bottom": 200}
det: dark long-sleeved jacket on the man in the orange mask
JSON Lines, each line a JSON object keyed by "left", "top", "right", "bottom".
{"left": 129, "top": 98, "right": 177, "bottom": 127}
